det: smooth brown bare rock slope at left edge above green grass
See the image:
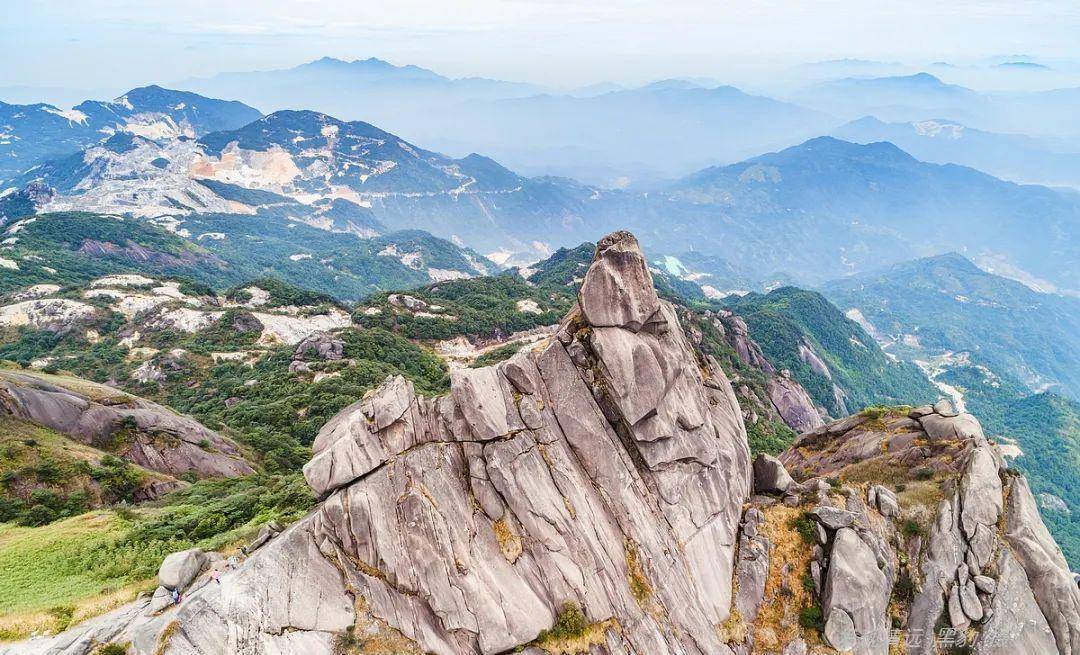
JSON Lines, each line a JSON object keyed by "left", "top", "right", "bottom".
{"left": 0, "top": 371, "right": 254, "bottom": 477}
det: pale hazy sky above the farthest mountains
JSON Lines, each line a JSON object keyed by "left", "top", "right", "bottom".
{"left": 0, "top": 0, "right": 1080, "bottom": 95}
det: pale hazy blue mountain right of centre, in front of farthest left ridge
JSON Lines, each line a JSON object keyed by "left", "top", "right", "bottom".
{"left": 405, "top": 80, "right": 837, "bottom": 186}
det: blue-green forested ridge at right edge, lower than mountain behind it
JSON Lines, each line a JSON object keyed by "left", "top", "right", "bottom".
{"left": 824, "top": 253, "right": 1080, "bottom": 399}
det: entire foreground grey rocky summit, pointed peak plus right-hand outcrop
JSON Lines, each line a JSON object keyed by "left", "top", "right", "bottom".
{"left": 10, "top": 232, "right": 1080, "bottom": 655}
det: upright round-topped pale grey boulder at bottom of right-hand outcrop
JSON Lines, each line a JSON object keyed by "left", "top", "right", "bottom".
{"left": 821, "top": 527, "right": 892, "bottom": 653}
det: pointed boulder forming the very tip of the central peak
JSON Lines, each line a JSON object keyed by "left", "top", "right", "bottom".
{"left": 578, "top": 232, "right": 660, "bottom": 333}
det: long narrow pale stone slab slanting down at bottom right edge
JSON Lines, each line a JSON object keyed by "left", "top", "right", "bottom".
{"left": 1005, "top": 477, "right": 1080, "bottom": 655}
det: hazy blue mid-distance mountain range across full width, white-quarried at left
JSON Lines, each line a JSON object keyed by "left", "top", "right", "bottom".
{"left": 8, "top": 89, "right": 1080, "bottom": 291}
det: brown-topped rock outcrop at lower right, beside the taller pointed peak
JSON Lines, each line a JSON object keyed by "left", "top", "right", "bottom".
{"left": 781, "top": 402, "right": 1080, "bottom": 655}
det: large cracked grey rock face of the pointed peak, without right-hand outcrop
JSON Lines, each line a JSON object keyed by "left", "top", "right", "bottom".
{"left": 78, "top": 233, "right": 751, "bottom": 655}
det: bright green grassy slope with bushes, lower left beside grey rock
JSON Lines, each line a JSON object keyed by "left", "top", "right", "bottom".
{"left": 0, "top": 474, "right": 314, "bottom": 638}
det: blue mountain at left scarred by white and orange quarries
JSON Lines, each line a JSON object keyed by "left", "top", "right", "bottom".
{"left": 0, "top": 111, "right": 598, "bottom": 258}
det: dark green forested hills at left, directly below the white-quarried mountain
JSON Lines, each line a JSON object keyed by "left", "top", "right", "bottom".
{"left": 0, "top": 211, "right": 494, "bottom": 300}
